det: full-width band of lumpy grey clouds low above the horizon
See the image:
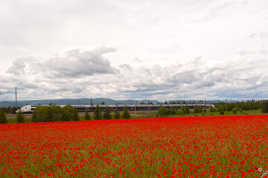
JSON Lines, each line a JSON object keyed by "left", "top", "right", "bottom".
{"left": 0, "top": 48, "right": 268, "bottom": 99}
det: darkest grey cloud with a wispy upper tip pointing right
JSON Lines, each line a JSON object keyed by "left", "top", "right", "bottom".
{"left": 39, "top": 48, "right": 116, "bottom": 78}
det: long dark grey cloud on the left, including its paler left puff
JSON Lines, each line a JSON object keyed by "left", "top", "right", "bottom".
{"left": 6, "top": 47, "right": 118, "bottom": 78}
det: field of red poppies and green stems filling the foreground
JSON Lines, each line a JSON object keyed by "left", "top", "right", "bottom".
{"left": 0, "top": 116, "right": 268, "bottom": 178}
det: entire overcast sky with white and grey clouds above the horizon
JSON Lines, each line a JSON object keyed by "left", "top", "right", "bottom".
{"left": 0, "top": 0, "right": 268, "bottom": 100}
